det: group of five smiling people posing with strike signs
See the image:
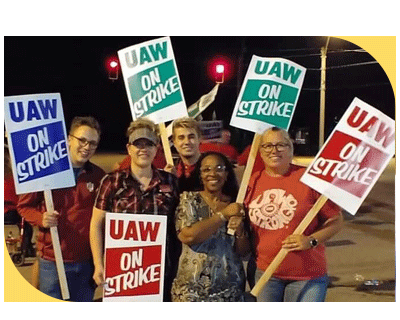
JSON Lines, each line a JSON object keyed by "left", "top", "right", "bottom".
{"left": 12, "top": 117, "right": 343, "bottom": 301}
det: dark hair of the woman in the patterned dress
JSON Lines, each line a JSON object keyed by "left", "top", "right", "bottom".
{"left": 193, "top": 151, "right": 239, "bottom": 201}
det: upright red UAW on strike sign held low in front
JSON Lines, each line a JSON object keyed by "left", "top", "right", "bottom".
{"left": 103, "top": 213, "right": 167, "bottom": 302}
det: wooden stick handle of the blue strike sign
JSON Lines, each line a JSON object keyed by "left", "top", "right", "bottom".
{"left": 43, "top": 189, "right": 70, "bottom": 300}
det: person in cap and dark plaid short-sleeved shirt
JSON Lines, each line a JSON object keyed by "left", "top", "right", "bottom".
{"left": 90, "top": 119, "right": 179, "bottom": 301}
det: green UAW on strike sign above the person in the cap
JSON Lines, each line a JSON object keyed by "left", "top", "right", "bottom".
{"left": 118, "top": 37, "right": 187, "bottom": 123}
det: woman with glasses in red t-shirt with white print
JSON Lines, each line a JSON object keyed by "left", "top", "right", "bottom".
{"left": 245, "top": 127, "right": 343, "bottom": 302}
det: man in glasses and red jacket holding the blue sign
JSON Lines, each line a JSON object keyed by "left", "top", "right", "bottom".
{"left": 18, "top": 117, "right": 105, "bottom": 301}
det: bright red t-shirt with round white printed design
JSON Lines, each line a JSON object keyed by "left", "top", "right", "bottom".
{"left": 245, "top": 165, "right": 340, "bottom": 280}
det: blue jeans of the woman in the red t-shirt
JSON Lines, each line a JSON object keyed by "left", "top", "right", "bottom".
{"left": 255, "top": 269, "right": 329, "bottom": 302}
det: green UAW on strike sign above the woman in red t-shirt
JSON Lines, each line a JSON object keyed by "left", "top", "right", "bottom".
{"left": 230, "top": 56, "right": 306, "bottom": 133}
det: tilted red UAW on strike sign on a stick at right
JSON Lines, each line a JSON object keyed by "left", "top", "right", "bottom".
{"left": 300, "top": 98, "right": 395, "bottom": 214}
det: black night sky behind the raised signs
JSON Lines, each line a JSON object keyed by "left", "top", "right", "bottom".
{"left": 4, "top": 35, "right": 395, "bottom": 154}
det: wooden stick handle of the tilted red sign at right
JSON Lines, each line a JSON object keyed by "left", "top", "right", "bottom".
{"left": 250, "top": 195, "right": 328, "bottom": 297}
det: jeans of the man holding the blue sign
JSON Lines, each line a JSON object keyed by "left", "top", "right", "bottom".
{"left": 39, "top": 259, "right": 96, "bottom": 302}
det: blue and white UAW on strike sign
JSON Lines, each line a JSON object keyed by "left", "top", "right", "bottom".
{"left": 4, "top": 93, "right": 75, "bottom": 194}
